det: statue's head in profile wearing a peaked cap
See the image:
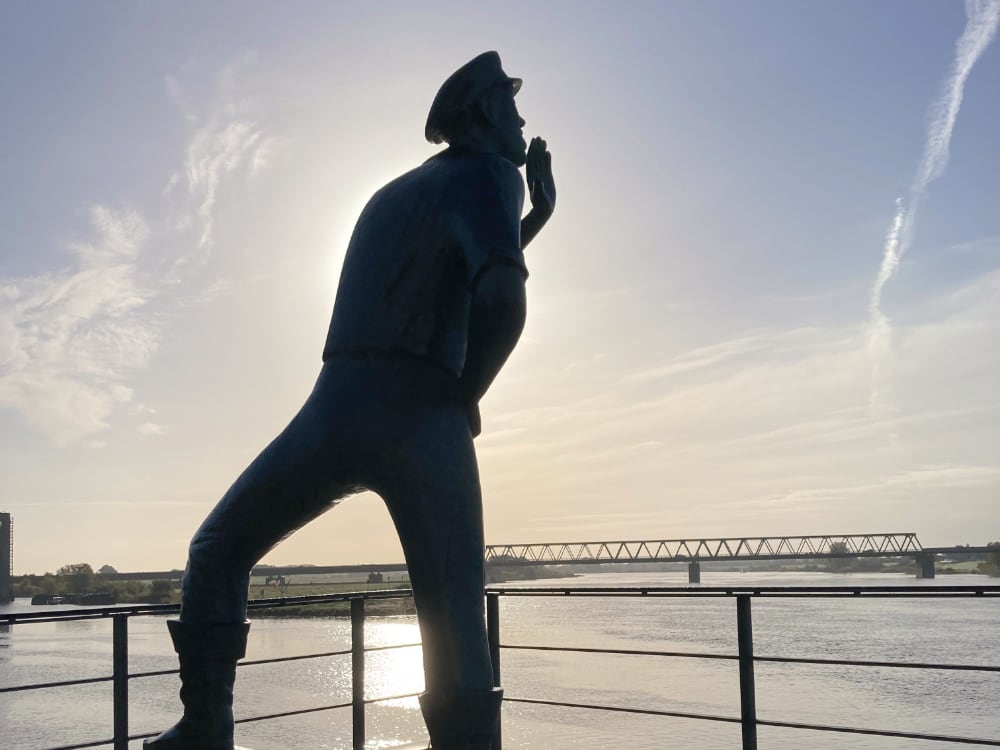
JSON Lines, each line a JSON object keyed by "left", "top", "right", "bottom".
{"left": 424, "top": 52, "right": 527, "bottom": 167}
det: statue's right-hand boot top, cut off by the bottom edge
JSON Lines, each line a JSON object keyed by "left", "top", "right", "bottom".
{"left": 420, "top": 688, "right": 503, "bottom": 750}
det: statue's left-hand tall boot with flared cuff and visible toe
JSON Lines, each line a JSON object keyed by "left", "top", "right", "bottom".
{"left": 142, "top": 620, "right": 250, "bottom": 750}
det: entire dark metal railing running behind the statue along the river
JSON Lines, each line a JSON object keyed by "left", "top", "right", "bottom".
{"left": 0, "top": 586, "right": 1000, "bottom": 750}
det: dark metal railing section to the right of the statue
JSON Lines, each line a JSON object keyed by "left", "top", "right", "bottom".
{"left": 486, "top": 586, "right": 1000, "bottom": 750}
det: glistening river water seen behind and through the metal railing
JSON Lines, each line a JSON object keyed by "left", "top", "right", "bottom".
{"left": 0, "top": 570, "right": 1000, "bottom": 750}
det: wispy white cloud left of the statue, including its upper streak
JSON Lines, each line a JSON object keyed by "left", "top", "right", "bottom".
{"left": 0, "top": 61, "right": 273, "bottom": 443}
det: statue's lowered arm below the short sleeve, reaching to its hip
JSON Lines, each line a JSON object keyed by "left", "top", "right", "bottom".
{"left": 459, "top": 263, "right": 527, "bottom": 436}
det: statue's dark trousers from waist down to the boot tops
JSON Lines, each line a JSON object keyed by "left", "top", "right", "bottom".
{"left": 180, "top": 356, "right": 493, "bottom": 691}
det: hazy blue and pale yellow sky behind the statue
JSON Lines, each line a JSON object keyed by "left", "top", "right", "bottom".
{"left": 0, "top": 0, "right": 1000, "bottom": 574}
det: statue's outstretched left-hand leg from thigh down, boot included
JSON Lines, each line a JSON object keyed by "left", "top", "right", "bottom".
{"left": 144, "top": 372, "right": 350, "bottom": 750}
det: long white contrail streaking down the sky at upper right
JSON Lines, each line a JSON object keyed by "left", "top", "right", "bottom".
{"left": 868, "top": 0, "right": 1000, "bottom": 405}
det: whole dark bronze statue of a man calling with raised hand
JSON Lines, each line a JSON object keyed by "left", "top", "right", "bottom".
{"left": 145, "top": 52, "right": 556, "bottom": 750}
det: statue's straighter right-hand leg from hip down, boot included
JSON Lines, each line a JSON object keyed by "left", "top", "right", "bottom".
{"left": 380, "top": 407, "right": 501, "bottom": 750}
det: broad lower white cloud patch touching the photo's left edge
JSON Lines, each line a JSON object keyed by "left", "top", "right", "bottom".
{"left": 0, "top": 206, "right": 158, "bottom": 442}
